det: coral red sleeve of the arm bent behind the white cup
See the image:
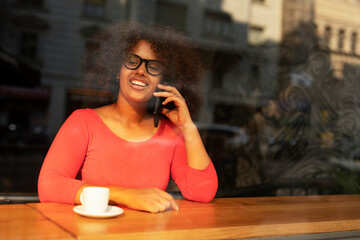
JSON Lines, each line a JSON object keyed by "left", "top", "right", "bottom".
{"left": 38, "top": 112, "right": 88, "bottom": 204}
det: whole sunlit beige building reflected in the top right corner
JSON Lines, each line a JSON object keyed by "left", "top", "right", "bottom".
{"left": 282, "top": 0, "right": 360, "bottom": 79}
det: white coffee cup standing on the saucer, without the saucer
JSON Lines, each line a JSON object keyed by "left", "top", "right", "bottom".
{"left": 80, "top": 187, "right": 109, "bottom": 214}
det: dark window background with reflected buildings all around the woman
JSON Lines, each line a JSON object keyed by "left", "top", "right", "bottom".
{"left": 0, "top": 0, "right": 360, "bottom": 203}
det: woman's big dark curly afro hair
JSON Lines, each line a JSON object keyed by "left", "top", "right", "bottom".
{"left": 82, "top": 22, "right": 203, "bottom": 116}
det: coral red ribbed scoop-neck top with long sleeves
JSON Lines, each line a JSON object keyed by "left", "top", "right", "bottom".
{"left": 38, "top": 109, "right": 218, "bottom": 204}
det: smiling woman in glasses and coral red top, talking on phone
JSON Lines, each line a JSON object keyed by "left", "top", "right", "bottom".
{"left": 38, "top": 21, "right": 217, "bottom": 212}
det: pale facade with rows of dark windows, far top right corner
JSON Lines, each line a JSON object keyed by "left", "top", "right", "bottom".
{"left": 314, "top": 0, "right": 360, "bottom": 79}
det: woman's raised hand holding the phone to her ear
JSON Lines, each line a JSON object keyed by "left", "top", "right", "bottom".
{"left": 154, "top": 84, "right": 194, "bottom": 129}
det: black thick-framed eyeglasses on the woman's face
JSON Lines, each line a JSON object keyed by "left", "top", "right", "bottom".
{"left": 123, "top": 54, "right": 165, "bottom": 76}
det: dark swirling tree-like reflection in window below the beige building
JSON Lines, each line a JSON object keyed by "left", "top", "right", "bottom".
{"left": 246, "top": 19, "right": 360, "bottom": 195}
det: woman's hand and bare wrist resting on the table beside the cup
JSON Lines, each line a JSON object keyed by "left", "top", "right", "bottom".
{"left": 110, "top": 186, "right": 179, "bottom": 213}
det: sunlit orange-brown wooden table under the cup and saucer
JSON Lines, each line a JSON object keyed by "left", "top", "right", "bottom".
{"left": 0, "top": 195, "right": 360, "bottom": 240}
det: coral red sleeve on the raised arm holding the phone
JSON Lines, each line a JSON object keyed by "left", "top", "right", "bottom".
{"left": 171, "top": 135, "right": 218, "bottom": 202}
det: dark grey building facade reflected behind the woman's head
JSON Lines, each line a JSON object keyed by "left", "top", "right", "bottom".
{"left": 1, "top": 0, "right": 282, "bottom": 138}
